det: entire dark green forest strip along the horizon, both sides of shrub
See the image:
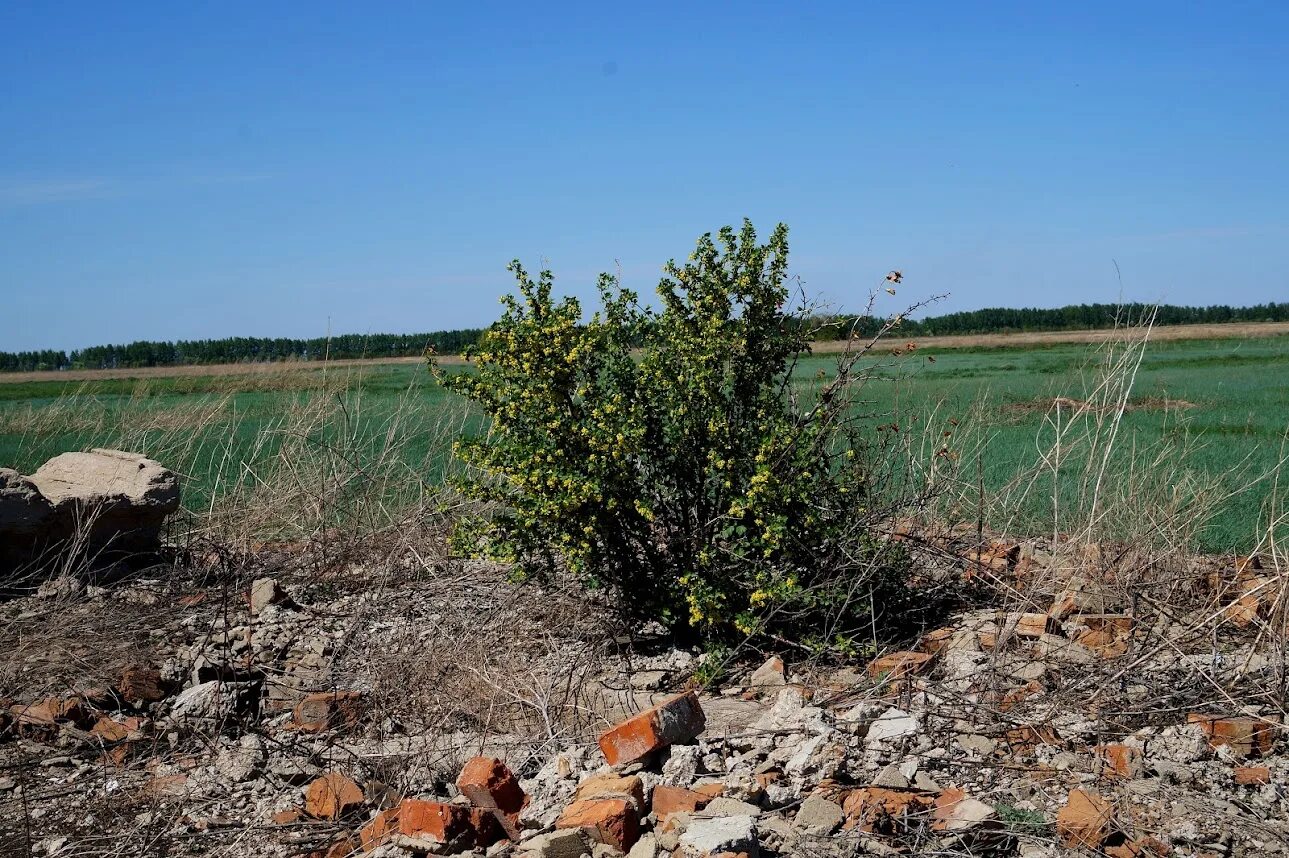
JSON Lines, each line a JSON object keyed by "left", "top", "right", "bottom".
{"left": 0, "top": 303, "right": 1289, "bottom": 372}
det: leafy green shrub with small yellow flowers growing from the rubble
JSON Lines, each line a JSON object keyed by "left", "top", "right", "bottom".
{"left": 440, "top": 222, "right": 912, "bottom": 648}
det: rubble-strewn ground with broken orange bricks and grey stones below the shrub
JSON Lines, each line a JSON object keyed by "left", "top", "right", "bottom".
{"left": 0, "top": 530, "right": 1289, "bottom": 858}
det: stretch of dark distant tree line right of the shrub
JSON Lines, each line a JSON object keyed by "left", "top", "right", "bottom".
{"left": 811, "top": 303, "right": 1289, "bottom": 339}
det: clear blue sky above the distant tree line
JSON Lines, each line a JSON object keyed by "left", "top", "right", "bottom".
{"left": 0, "top": 0, "right": 1289, "bottom": 350}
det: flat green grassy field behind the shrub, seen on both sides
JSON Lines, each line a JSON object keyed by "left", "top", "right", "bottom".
{"left": 0, "top": 329, "right": 1289, "bottom": 551}
